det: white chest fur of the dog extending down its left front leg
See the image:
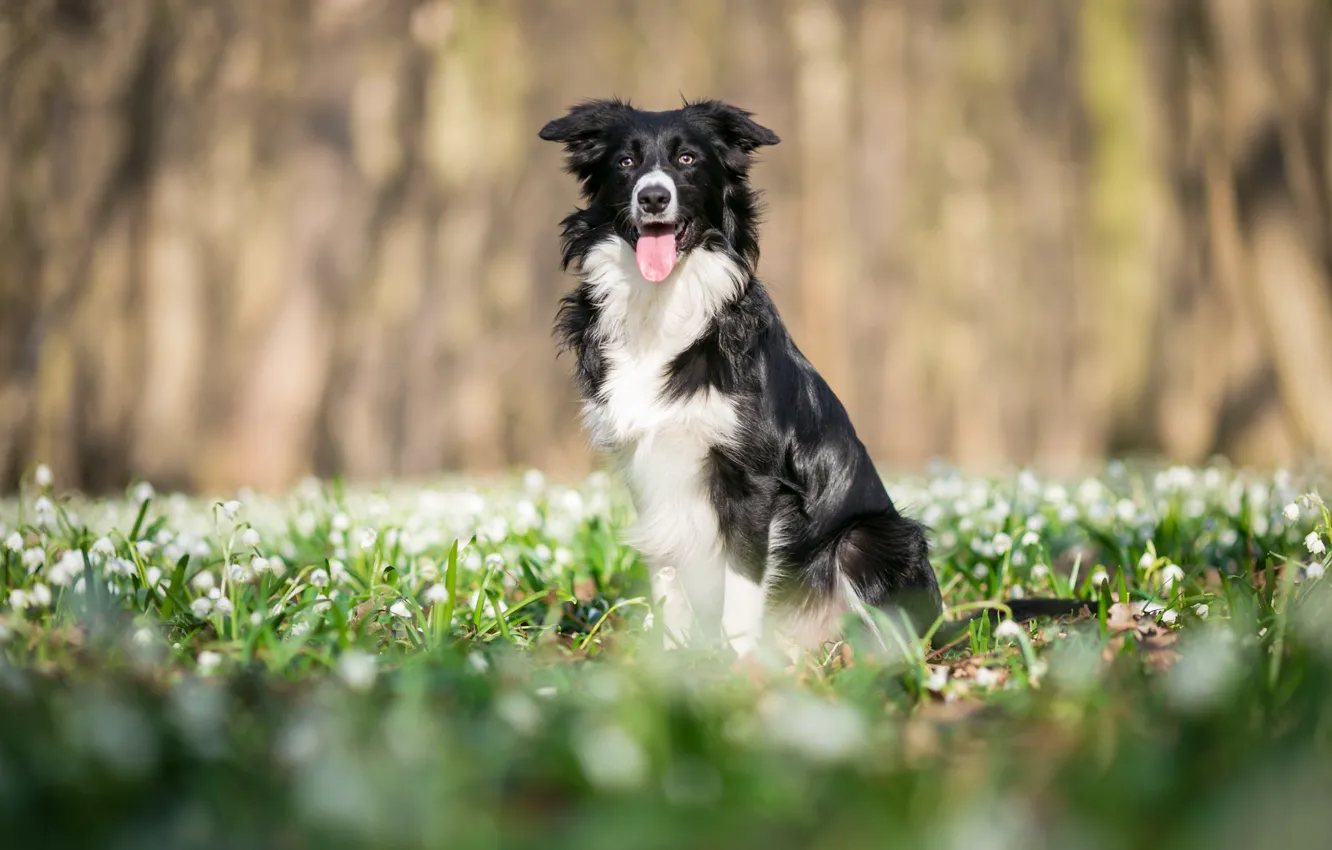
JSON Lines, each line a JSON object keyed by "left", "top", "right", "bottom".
{"left": 582, "top": 237, "right": 745, "bottom": 637}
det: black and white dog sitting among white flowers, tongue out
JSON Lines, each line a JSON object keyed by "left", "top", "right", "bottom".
{"left": 539, "top": 100, "right": 1075, "bottom": 654}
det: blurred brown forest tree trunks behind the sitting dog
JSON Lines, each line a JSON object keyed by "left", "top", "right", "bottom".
{"left": 0, "top": 0, "right": 1332, "bottom": 490}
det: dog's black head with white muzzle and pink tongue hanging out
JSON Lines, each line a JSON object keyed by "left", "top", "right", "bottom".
{"left": 539, "top": 100, "right": 779, "bottom": 282}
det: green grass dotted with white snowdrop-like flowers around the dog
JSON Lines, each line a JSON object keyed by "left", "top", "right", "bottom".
{"left": 0, "top": 464, "right": 1332, "bottom": 850}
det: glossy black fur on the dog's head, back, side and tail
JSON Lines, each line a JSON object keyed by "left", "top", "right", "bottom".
{"left": 539, "top": 94, "right": 1080, "bottom": 652}
